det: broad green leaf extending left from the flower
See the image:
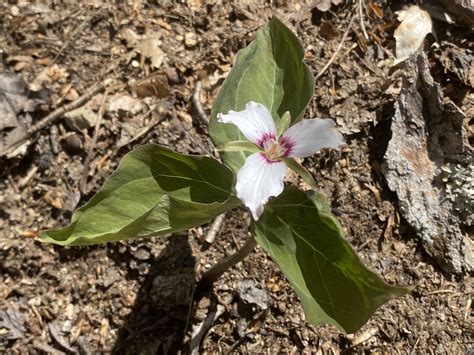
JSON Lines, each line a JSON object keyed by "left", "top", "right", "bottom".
{"left": 40, "top": 144, "right": 240, "bottom": 245}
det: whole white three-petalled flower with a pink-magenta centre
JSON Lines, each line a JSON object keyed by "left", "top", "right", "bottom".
{"left": 217, "top": 101, "right": 344, "bottom": 221}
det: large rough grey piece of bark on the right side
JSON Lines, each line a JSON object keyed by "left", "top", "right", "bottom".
{"left": 384, "top": 53, "right": 474, "bottom": 273}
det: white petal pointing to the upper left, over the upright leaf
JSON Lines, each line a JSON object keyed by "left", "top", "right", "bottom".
{"left": 217, "top": 101, "right": 277, "bottom": 147}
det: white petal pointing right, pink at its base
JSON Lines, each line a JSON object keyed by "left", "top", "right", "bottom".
{"left": 280, "top": 118, "right": 344, "bottom": 158}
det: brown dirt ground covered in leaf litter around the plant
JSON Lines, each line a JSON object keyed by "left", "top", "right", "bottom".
{"left": 0, "top": 0, "right": 474, "bottom": 354}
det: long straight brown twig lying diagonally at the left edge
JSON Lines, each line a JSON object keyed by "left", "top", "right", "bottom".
{"left": 0, "top": 79, "right": 111, "bottom": 156}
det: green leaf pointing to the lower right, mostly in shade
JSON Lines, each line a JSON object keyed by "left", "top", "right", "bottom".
{"left": 253, "top": 187, "right": 409, "bottom": 333}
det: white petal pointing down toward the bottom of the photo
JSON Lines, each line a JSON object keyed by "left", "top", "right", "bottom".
{"left": 235, "top": 153, "right": 286, "bottom": 221}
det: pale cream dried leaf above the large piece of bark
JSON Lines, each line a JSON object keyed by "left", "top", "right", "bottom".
{"left": 394, "top": 5, "right": 433, "bottom": 65}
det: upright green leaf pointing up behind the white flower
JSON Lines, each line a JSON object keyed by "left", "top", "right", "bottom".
{"left": 209, "top": 17, "right": 314, "bottom": 171}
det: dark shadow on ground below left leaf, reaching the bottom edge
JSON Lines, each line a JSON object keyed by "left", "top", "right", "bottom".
{"left": 113, "top": 235, "right": 195, "bottom": 354}
